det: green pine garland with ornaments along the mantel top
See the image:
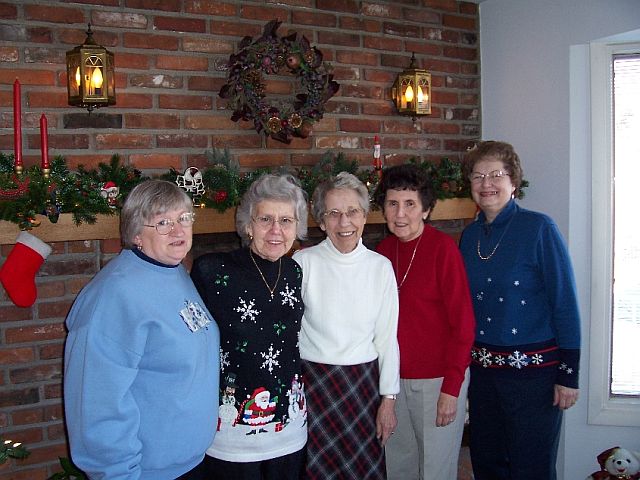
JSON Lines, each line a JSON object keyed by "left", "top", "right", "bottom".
{"left": 0, "top": 149, "right": 528, "bottom": 230}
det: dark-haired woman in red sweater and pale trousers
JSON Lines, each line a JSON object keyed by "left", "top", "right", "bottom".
{"left": 375, "top": 164, "right": 475, "bottom": 480}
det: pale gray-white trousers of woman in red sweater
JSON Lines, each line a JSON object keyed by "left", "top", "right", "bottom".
{"left": 385, "top": 369, "right": 469, "bottom": 480}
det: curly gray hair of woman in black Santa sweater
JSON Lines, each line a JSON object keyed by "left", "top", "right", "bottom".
{"left": 236, "top": 173, "right": 309, "bottom": 246}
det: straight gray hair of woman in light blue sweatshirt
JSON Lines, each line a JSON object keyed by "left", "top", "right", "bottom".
{"left": 120, "top": 180, "right": 193, "bottom": 248}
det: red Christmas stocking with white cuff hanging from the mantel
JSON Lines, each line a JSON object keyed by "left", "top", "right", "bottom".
{"left": 0, "top": 232, "right": 51, "bottom": 307}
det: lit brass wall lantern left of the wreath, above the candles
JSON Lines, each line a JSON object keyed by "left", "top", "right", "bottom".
{"left": 67, "top": 24, "right": 116, "bottom": 113}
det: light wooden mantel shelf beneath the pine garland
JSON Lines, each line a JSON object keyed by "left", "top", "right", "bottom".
{"left": 0, "top": 198, "right": 476, "bottom": 245}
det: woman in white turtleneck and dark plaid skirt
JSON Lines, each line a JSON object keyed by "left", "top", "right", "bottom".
{"left": 294, "top": 172, "right": 399, "bottom": 480}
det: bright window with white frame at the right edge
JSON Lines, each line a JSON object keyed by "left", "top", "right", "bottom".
{"left": 589, "top": 40, "right": 640, "bottom": 426}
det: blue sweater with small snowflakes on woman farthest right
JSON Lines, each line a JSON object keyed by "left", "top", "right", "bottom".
{"left": 460, "top": 200, "right": 580, "bottom": 388}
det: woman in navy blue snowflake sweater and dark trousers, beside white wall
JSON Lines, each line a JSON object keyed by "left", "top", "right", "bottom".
{"left": 460, "top": 141, "right": 580, "bottom": 480}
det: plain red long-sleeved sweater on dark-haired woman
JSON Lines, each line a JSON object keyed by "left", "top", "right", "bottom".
{"left": 377, "top": 225, "right": 475, "bottom": 397}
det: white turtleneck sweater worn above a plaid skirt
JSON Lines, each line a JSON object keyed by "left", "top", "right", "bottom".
{"left": 293, "top": 239, "right": 400, "bottom": 395}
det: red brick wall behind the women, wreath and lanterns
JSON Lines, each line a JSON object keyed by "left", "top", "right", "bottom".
{"left": 0, "top": 0, "right": 480, "bottom": 480}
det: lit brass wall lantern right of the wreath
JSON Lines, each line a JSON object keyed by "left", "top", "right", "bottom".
{"left": 391, "top": 54, "right": 431, "bottom": 120}
